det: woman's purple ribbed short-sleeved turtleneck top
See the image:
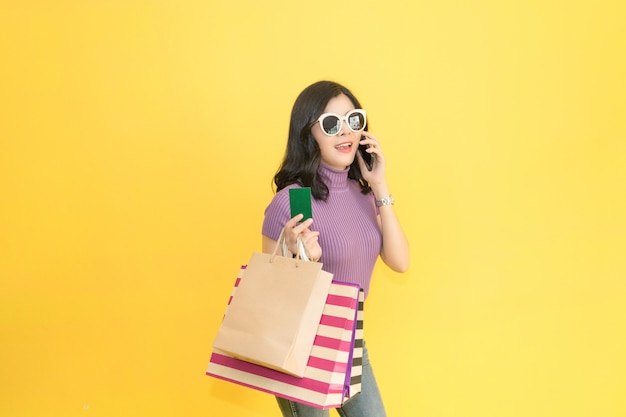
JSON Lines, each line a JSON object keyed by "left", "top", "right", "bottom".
{"left": 262, "top": 165, "right": 382, "bottom": 297}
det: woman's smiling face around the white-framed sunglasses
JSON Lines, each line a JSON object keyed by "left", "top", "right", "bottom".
{"left": 311, "top": 94, "right": 361, "bottom": 170}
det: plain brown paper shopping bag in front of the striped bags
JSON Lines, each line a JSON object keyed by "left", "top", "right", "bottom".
{"left": 213, "top": 237, "right": 333, "bottom": 377}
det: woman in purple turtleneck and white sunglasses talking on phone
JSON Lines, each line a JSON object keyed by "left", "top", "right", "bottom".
{"left": 262, "top": 81, "right": 409, "bottom": 417}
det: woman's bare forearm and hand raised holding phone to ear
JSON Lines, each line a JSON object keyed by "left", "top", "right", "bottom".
{"left": 357, "top": 132, "right": 410, "bottom": 272}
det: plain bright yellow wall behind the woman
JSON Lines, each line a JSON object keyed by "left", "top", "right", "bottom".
{"left": 0, "top": 0, "right": 626, "bottom": 417}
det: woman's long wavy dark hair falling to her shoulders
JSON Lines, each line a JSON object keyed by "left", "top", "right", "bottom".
{"left": 274, "top": 81, "right": 371, "bottom": 200}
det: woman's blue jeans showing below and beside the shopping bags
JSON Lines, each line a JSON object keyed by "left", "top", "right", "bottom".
{"left": 276, "top": 344, "right": 387, "bottom": 417}
